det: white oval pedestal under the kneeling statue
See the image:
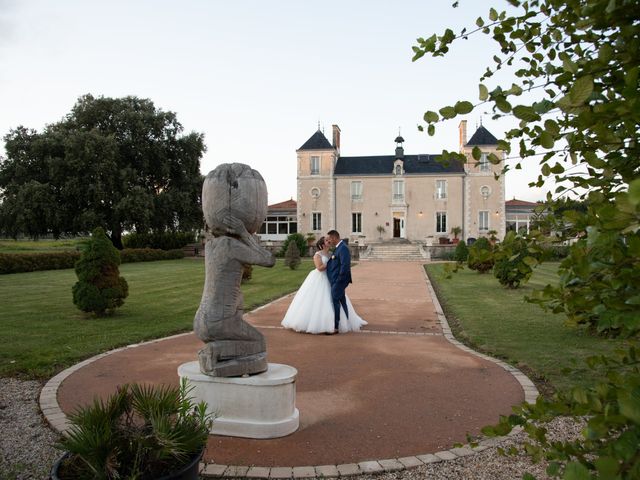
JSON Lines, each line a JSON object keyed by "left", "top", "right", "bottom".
{"left": 178, "top": 361, "right": 300, "bottom": 438}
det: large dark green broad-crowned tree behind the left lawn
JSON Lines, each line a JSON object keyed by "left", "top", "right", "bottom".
{"left": 0, "top": 95, "right": 205, "bottom": 248}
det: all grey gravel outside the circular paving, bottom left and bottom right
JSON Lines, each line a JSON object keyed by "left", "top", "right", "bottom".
{"left": 0, "top": 378, "right": 583, "bottom": 480}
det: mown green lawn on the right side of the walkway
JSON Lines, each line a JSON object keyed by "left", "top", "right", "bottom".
{"left": 426, "top": 264, "right": 624, "bottom": 392}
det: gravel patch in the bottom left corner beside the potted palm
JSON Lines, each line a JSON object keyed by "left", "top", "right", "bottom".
{"left": 0, "top": 378, "right": 60, "bottom": 480}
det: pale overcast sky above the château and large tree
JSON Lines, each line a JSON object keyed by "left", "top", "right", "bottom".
{"left": 0, "top": 0, "right": 544, "bottom": 203}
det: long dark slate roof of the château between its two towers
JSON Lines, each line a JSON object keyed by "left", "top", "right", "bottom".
{"left": 333, "top": 155, "right": 464, "bottom": 175}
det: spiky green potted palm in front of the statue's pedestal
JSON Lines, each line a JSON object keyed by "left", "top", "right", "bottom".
{"left": 51, "top": 379, "right": 212, "bottom": 480}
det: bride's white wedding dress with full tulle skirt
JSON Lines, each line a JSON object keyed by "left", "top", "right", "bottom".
{"left": 282, "top": 252, "right": 367, "bottom": 333}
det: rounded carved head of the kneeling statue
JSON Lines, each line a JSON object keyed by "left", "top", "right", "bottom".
{"left": 202, "top": 163, "right": 267, "bottom": 236}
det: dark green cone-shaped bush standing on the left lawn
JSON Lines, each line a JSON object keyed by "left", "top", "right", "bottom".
{"left": 72, "top": 228, "right": 129, "bottom": 315}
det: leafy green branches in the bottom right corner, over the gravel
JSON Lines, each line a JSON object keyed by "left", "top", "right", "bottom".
{"left": 483, "top": 347, "right": 640, "bottom": 480}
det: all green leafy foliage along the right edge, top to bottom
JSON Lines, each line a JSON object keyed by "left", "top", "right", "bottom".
{"left": 413, "top": 0, "right": 640, "bottom": 480}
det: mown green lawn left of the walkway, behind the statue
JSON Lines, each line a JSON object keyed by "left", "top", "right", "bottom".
{"left": 0, "top": 259, "right": 313, "bottom": 378}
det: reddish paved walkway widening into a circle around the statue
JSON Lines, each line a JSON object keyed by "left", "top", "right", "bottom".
{"left": 41, "top": 262, "right": 537, "bottom": 477}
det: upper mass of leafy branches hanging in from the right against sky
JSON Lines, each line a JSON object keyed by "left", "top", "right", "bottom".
{"left": 413, "top": 0, "right": 640, "bottom": 335}
